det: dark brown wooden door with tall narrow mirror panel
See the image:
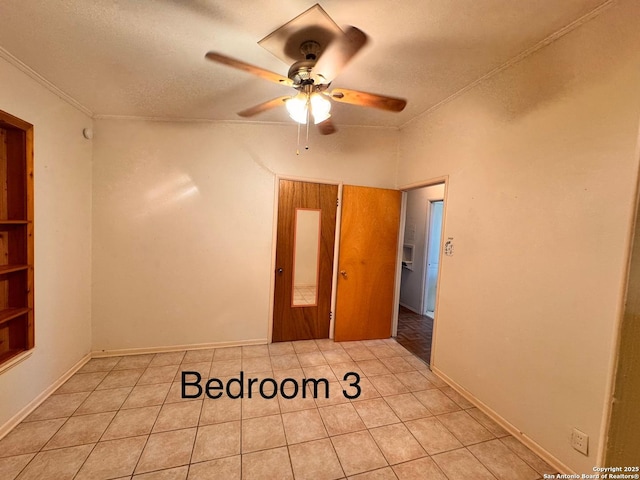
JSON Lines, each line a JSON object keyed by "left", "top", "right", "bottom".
{"left": 272, "top": 180, "right": 338, "bottom": 342}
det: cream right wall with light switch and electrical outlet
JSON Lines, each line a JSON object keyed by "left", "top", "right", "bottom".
{"left": 399, "top": 0, "right": 640, "bottom": 473}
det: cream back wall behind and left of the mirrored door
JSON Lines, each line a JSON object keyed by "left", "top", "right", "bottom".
{"left": 93, "top": 120, "right": 398, "bottom": 351}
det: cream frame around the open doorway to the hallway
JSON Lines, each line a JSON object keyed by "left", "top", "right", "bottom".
{"left": 392, "top": 175, "right": 449, "bottom": 367}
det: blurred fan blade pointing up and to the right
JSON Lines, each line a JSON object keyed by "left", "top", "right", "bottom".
{"left": 312, "top": 27, "right": 367, "bottom": 85}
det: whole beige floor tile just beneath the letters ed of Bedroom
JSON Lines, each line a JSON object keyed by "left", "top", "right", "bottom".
{"left": 191, "top": 421, "right": 241, "bottom": 463}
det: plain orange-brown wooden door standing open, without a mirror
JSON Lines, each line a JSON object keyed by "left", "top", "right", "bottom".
{"left": 334, "top": 185, "right": 402, "bottom": 341}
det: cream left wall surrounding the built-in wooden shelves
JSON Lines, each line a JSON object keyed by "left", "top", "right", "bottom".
{"left": 0, "top": 59, "right": 91, "bottom": 426}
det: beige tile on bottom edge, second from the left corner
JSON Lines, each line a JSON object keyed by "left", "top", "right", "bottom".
{"left": 18, "top": 445, "right": 93, "bottom": 480}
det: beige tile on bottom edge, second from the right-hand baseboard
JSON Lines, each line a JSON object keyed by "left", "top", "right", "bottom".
{"left": 469, "top": 440, "right": 540, "bottom": 480}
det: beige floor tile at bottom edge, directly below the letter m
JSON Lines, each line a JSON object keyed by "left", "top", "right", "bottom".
{"left": 289, "top": 439, "right": 344, "bottom": 480}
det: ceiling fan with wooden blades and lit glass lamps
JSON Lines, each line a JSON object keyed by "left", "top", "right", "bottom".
{"left": 206, "top": 5, "right": 407, "bottom": 135}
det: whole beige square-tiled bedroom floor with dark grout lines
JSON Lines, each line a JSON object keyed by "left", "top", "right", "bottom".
{"left": 0, "top": 339, "right": 553, "bottom": 480}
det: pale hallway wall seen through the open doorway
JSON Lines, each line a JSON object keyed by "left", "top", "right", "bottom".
{"left": 400, "top": 184, "right": 444, "bottom": 314}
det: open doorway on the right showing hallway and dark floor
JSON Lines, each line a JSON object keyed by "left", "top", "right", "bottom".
{"left": 396, "top": 182, "right": 445, "bottom": 364}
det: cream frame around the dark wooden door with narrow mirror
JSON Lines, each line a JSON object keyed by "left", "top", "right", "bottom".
{"left": 267, "top": 174, "right": 343, "bottom": 343}
